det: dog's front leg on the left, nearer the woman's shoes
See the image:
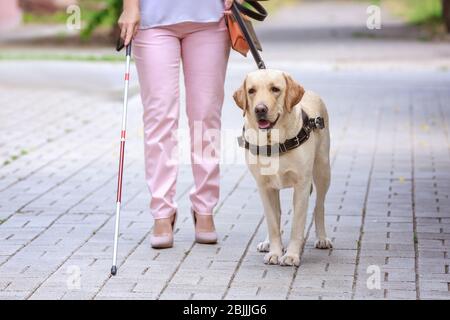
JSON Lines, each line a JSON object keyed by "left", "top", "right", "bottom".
{"left": 258, "top": 185, "right": 283, "bottom": 264}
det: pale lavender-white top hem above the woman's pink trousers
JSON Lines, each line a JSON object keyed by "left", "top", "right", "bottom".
{"left": 140, "top": 0, "right": 224, "bottom": 29}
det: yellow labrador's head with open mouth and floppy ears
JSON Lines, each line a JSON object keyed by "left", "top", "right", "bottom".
{"left": 233, "top": 69, "right": 305, "bottom": 130}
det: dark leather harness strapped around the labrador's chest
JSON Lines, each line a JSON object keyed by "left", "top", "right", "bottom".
{"left": 237, "top": 110, "right": 325, "bottom": 157}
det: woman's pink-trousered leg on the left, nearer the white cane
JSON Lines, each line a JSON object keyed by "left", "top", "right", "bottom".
{"left": 133, "top": 28, "right": 180, "bottom": 224}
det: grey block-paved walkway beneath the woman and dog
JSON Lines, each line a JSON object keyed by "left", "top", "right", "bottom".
{"left": 0, "top": 0, "right": 450, "bottom": 299}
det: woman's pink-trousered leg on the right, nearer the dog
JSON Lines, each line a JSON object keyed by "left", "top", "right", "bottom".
{"left": 181, "top": 19, "right": 230, "bottom": 223}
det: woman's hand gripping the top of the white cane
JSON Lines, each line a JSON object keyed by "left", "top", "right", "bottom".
{"left": 118, "top": 0, "right": 141, "bottom": 46}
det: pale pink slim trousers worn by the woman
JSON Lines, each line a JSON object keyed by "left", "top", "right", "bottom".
{"left": 133, "top": 19, "right": 230, "bottom": 219}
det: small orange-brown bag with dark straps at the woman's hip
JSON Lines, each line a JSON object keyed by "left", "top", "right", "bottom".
{"left": 225, "top": 0, "right": 267, "bottom": 57}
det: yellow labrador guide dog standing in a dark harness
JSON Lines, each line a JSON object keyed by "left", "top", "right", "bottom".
{"left": 233, "top": 69, "right": 332, "bottom": 266}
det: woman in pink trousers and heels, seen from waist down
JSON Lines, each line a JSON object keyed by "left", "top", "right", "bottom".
{"left": 119, "top": 0, "right": 233, "bottom": 248}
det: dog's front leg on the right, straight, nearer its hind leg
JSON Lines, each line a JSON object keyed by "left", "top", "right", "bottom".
{"left": 280, "top": 179, "right": 311, "bottom": 266}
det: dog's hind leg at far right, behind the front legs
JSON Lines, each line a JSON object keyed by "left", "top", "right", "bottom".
{"left": 313, "top": 153, "right": 333, "bottom": 249}
